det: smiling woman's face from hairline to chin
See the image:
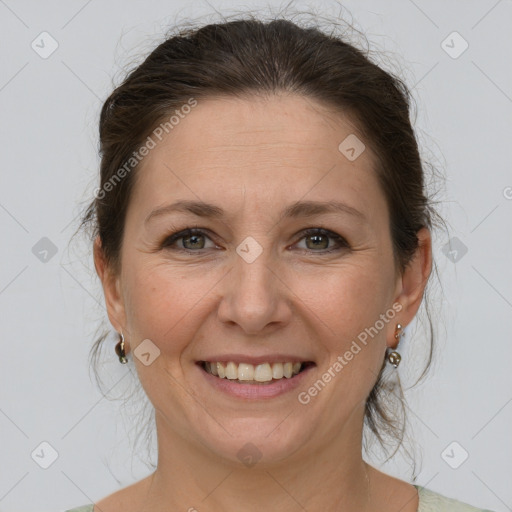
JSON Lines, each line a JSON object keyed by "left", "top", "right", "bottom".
{"left": 98, "top": 96, "right": 421, "bottom": 463}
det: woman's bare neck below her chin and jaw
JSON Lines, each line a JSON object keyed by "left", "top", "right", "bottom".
{"left": 138, "top": 406, "right": 373, "bottom": 512}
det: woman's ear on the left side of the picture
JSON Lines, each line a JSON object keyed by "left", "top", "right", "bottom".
{"left": 93, "top": 235, "right": 126, "bottom": 344}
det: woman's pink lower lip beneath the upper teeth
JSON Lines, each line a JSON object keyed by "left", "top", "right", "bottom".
{"left": 197, "top": 364, "right": 315, "bottom": 400}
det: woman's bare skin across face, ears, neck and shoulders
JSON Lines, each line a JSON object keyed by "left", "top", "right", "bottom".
{"left": 94, "top": 95, "right": 431, "bottom": 512}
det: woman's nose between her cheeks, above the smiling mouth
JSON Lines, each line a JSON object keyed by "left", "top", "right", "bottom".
{"left": 218, "top": 250, "right": 292, "bottom": 335}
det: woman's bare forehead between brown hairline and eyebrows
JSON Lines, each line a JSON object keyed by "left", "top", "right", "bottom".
{"left": 130, "top": 95, "right": 384, "bottom": 222}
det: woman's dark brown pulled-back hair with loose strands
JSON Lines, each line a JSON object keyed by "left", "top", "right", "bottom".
{"left": 78, "top": 17, "right": 438, "bottom": 474}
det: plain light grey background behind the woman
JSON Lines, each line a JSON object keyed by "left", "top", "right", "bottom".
{"left": 0, "top": 0, "right": 512, "bottom": 512}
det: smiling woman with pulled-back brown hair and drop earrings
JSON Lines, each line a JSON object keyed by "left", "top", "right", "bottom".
{"left": 68, "top": 19, "right": 496, "bottom": 512}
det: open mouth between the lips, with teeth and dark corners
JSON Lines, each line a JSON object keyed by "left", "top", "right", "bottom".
{"left": 197, "top": 361, "right": 315, "bottom": 385}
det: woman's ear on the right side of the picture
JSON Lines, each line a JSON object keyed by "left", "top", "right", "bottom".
{"left": 388, "top": 228, "right": 432, "bottom": 348}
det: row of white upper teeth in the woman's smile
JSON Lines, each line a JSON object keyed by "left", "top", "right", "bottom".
{"left": 205, "top": 361, "right": 302, "bottom": 382}
